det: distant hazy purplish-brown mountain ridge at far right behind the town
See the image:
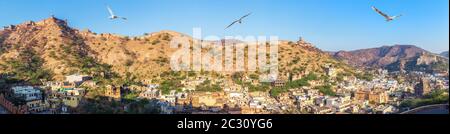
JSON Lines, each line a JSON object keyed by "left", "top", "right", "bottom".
{"left": 329, "top": 45, "right": 448, "bottom": 72}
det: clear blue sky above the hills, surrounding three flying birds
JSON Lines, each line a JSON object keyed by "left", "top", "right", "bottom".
{"left": 0, "top": 0, "right": 449, "bottom": 53}
